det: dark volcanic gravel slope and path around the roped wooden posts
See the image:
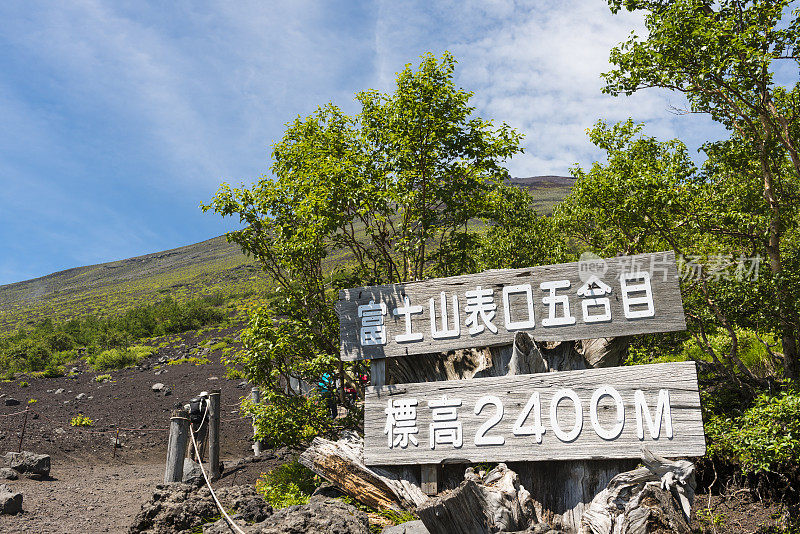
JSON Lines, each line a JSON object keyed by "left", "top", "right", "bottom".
{"left": 0, "top": 329, "right": 288, "bottom": 534}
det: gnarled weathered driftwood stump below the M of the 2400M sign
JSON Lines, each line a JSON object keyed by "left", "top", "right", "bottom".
{"left": 580, "top": 450, "right": 695, "bottom": 534}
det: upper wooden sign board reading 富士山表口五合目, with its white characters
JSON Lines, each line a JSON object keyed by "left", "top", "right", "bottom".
{"left": 337, "top": 251, "right": 686, "bottom": 360}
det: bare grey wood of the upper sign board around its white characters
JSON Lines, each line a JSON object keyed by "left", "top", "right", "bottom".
{"left": 337, "top": 252, "right": 686, "bottom": 360}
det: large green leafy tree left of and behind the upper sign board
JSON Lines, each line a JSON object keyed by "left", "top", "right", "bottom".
{"left": 202, "top": 53, "right": 523, "bottom": 448}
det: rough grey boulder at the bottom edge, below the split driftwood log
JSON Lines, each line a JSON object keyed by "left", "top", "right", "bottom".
{"left": 203, "top": 497, "right": 370, "bottom": 534}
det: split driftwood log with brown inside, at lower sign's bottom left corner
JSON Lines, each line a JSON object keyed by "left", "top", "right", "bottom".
{"left": 299, "top": 432, "right": 428, "bottom": 510}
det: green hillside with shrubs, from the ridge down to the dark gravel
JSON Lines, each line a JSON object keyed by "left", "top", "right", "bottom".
{"left": 0, "top": 176, "right": 574, "bottom": 379}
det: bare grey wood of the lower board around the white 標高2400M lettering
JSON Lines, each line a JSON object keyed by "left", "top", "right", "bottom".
{"left": 364, "top": 362, "right": 705, "bottom": 465}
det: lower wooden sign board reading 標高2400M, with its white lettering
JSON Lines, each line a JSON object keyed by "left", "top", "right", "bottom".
{"left": 364, "top": 362, "right": 706, "bottom": 465}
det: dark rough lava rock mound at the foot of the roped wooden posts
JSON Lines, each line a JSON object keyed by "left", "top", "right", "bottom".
{"left": 128, "top": 484, "right": 272, "bottom": 534}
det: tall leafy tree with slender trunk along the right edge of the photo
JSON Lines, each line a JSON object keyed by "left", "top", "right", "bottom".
{"left": 604, "top": 0, "right": 800, "bottom": 378}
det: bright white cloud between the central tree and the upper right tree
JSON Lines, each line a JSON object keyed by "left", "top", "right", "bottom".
{"left": 368, "top": 1, "right": 720, "bottom": 176}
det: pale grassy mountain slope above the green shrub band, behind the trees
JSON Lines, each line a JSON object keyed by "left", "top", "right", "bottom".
{"left": 0, "top": 176, "right": 575, "bottom": 333}
